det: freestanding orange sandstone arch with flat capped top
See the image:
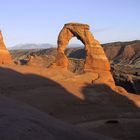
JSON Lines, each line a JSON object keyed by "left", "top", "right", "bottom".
{"left": 56, "top": 23, "right": 110, "bottom": 71}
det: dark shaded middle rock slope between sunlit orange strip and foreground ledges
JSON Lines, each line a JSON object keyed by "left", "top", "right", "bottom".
{"left": 0, "top": 67, "right": 140, "bottom": 123}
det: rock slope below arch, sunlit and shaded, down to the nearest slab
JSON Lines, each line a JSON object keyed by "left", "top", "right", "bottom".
{"left": 0, "top": 65, "right": 140, "bottom": 140}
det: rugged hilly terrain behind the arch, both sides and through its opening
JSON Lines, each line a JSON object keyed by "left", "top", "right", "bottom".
{"left": 10, "top": 40, "right": 140, "bottom": 93}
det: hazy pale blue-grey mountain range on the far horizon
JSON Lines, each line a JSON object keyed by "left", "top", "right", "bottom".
{"left": 8, "top": 43, "right": 82, "bottom": 50}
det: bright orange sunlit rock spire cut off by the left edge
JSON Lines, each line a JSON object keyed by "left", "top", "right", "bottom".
{"left": 0, "top": 31, "right": 13, "bottom": 65}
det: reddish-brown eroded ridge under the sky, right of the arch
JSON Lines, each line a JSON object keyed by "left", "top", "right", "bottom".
{"left": 102, "top": 40, "right": 140, "bottom": 68}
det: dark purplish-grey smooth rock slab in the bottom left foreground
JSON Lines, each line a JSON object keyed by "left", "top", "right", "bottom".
{"left": 0, "top": 96, "right": 113, "bottom": 140}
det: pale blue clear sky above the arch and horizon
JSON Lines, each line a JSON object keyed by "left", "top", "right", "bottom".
{"left": 0, "top": 0, "right": 140, "bottom": 47}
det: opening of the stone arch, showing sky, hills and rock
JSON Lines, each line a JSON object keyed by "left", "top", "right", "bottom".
{"left": 65, "top": 36, "right": 86, "bottom": 74}
